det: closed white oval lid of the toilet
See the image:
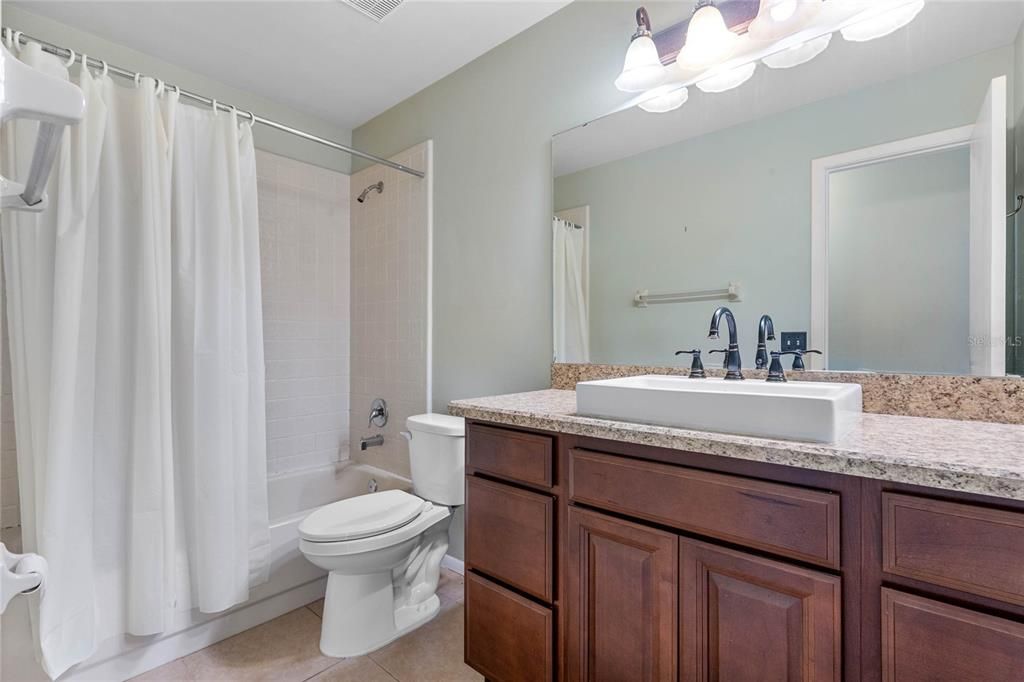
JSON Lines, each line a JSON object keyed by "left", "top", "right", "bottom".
{"left": 299, "top": 491, "right": 430, "bottom": 543}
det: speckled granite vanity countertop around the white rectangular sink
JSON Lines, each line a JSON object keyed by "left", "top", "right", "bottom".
{"left": 449, "top": 389, "right": 1024, "bottom": 500}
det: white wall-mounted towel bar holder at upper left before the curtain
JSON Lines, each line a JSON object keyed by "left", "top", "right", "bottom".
{"left": 0, "top": 45, "right": 85, "bottom": 211}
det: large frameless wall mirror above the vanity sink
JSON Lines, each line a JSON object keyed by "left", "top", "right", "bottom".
{"left": 552, "top": 0, "right": 1024, "bottom": 376}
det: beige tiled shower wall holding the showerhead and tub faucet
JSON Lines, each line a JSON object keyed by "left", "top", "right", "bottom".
{"left": 351, "top": 141, "right": 432, "bottom": 476}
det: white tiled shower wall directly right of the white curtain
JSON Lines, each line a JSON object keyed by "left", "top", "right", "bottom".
{"left": 256, "top": 152, "right": 349, "bottom": 474}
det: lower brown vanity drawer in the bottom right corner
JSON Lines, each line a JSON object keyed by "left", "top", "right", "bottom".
{"left": 882, "top": 588, "right": 1024, "bottom": 682}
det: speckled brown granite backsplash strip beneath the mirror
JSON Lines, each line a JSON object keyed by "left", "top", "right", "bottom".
{"left": 551, "top": 363, "right": 1024, "bottom": 424}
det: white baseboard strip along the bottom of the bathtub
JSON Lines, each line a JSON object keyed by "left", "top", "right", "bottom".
{"left": 61, "top": 577, "right": 327, "bottom": 682}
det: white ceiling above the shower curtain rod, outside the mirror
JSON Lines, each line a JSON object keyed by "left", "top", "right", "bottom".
{"left": 11, "top": 0, "right": 568, "bottom": 128}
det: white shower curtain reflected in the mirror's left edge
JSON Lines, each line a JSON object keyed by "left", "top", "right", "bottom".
{"left": 552, "top": 218, "right": 590, "bottom": 363}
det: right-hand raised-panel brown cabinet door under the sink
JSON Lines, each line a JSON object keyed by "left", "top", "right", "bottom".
{"left": 680, "top": 540, "right": 842, "bottom": 682}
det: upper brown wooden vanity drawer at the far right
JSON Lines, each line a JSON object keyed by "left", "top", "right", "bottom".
{"left": 882, "top": 493, "right": 1024, "bottom": 604}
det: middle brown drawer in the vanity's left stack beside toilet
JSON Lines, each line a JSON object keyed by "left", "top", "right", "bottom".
{"left": 466, "top": 476, "right": 555, "bottom": 602}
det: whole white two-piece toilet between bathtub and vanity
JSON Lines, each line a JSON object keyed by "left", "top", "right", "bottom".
{"left": 299, "top": 414, "right": 466, "bottom": 657}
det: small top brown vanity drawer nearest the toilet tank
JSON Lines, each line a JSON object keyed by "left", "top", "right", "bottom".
{"left": 467, "top": 424, "right": 554, "bottom": 487}
